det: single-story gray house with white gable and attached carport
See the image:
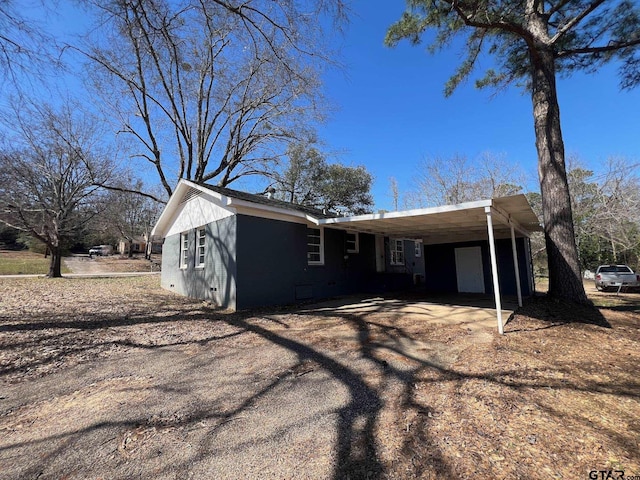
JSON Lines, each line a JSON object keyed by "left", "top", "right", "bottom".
{"left": 152, "top": 180, "right": 540, "bottom": 329}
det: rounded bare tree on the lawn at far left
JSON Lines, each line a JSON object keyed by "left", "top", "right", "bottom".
{"left": 0, "top": 105, "right": 113, "bottom": 277}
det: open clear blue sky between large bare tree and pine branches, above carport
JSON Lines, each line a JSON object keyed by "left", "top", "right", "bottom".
{"left": 320, "top": 0, "right": 640, "bottom": 209}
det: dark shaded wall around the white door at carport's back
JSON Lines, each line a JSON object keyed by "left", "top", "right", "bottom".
{"left": 424, "top": 238, "right": 531, "bottom": 295}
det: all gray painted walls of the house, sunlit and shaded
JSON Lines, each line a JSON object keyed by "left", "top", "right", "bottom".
{"left": 161, "top": 215, "right": 530, "bottom": 309}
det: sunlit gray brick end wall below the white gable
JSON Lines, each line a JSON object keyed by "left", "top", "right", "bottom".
{"left": 161, "top": 216, "right": 237, "bottom": 309}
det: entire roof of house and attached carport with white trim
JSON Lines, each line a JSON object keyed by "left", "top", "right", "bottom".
{"left": 152, "top": 180, "right": 541, "bottom": 244}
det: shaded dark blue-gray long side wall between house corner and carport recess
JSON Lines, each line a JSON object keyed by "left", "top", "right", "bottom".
{"left": 236, "top": 215, "right": 375, "bottom": 309}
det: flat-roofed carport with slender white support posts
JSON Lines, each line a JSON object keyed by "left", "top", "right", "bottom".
{"left": 319, "top": 195, "right": 542, "bottom": 334}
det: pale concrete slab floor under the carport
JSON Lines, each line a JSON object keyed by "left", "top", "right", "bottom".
{"left": 304, "top": 293, "right": 518, "bottom": 335}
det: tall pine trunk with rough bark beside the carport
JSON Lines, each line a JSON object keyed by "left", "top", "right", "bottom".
{"left": 530, "top": 47, "right": 589, "bottom": 303}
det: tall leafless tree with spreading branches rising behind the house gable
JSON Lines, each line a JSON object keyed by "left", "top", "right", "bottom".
{"left": 78, "top": 0, "right": 348, "bottom": 194}
